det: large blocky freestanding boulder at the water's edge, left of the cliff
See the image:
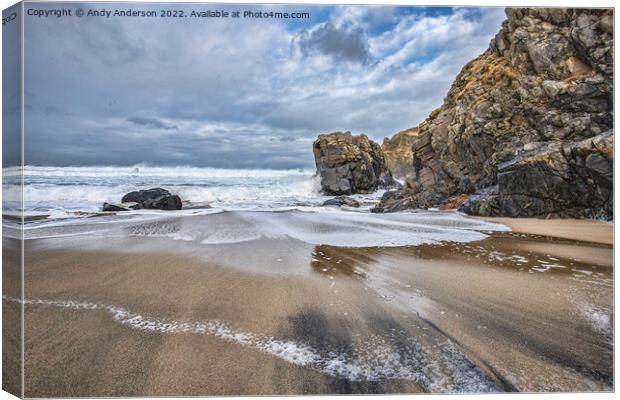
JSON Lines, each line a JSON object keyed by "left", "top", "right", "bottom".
{"left": 313, "top": 132, "right": 395, "bottom": 195}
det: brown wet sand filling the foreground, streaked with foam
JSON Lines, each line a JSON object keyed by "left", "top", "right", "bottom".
{"left": 3, "top": 214, "right": 613, "bottom": 397}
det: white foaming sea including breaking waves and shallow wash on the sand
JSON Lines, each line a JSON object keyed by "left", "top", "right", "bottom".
{"left": 3, "top": 165, "right": 507, "bottom": 247}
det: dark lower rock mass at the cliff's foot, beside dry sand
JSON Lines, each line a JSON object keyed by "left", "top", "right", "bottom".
{"left": 462, "top": 131, "right": 614, "bottom": 218}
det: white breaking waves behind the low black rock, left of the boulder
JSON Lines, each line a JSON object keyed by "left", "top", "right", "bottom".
{"left": 3, "top": 165, "right": 358, "bottom": 216}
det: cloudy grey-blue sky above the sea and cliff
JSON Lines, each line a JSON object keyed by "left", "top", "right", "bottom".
{"left": 25, "top": 3, "right": 504, "bottom": 168}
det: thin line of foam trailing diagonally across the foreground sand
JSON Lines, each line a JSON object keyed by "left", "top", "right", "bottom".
{"left": 3, "top": 296, "right": 498, "bottom": 393}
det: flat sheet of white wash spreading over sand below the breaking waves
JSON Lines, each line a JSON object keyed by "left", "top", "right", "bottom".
{"left": 20, "top": 208, "right": 509, "bottom": 247}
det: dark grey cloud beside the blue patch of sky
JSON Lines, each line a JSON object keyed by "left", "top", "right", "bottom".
{"left": 293, "top": 22, "right": 370, "bottom": 64}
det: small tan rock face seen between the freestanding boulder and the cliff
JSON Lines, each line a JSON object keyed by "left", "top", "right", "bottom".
{"left": 381, "top": 128, "right": 418, "bottom": 179}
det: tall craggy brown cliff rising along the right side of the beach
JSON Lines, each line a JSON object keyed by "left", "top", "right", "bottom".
{"left": 375, "top": 8, "right": 613, "bottom": 219}
